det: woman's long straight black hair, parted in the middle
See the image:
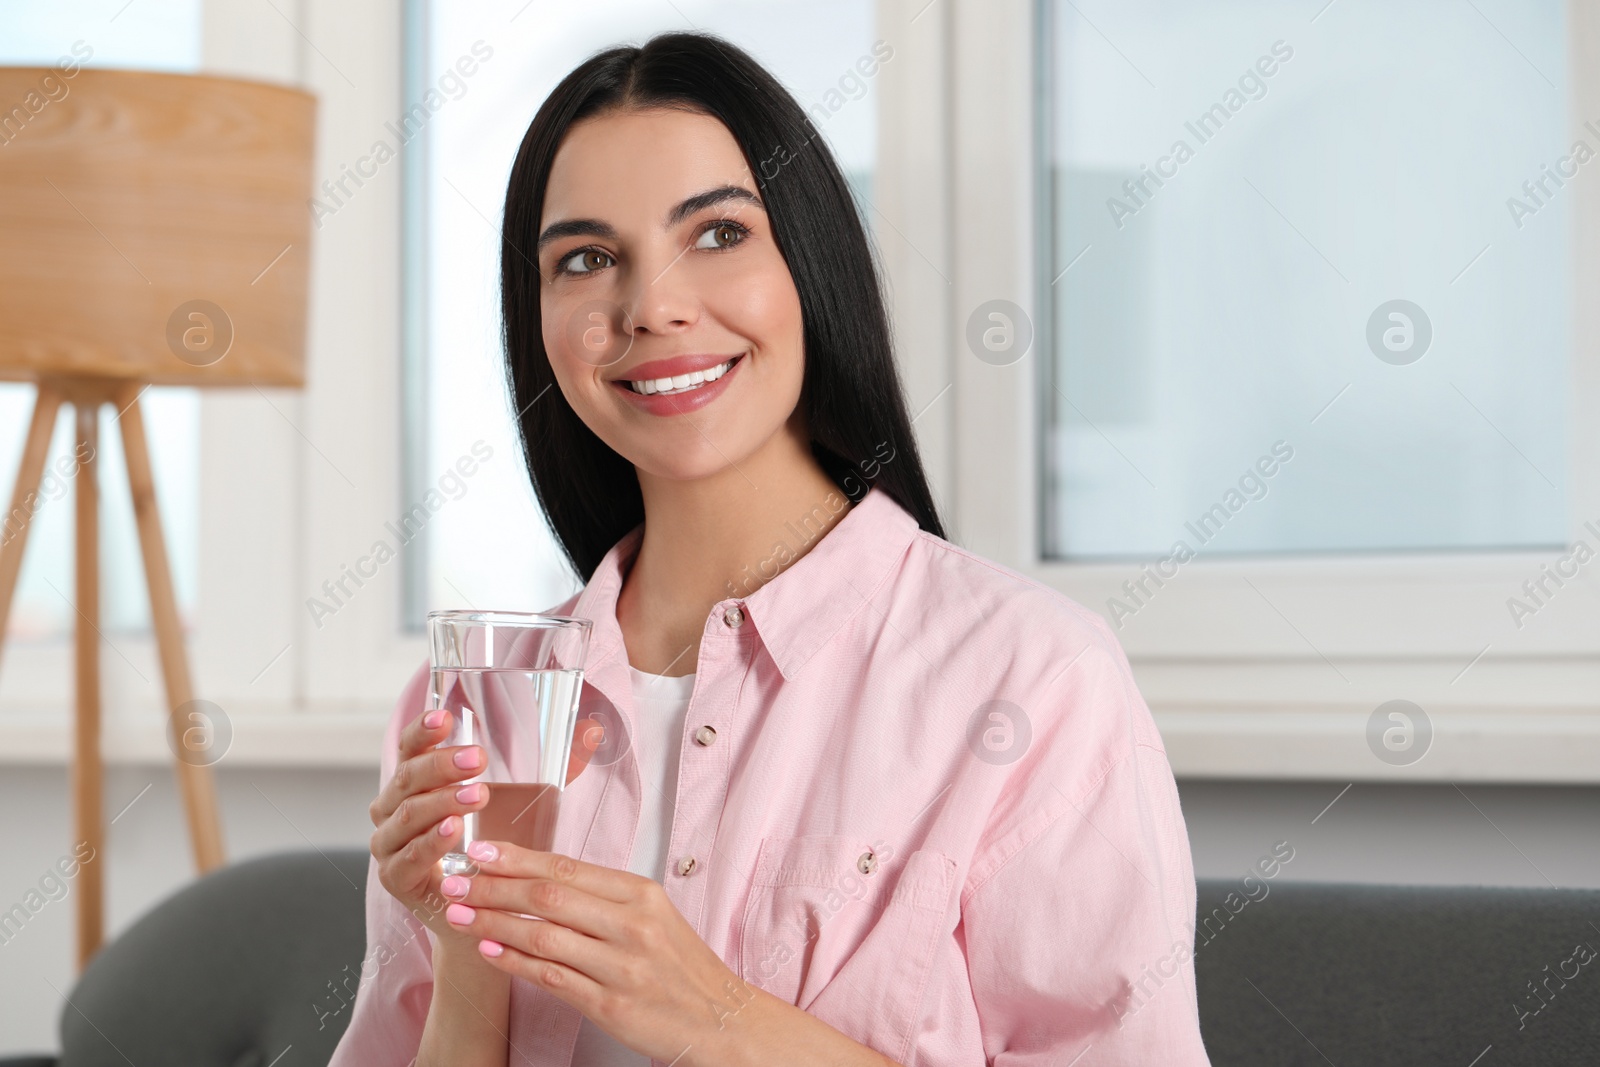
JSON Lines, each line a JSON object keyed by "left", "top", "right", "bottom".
{"left": 501, "top": 34, "right": 944, "bottom": 582}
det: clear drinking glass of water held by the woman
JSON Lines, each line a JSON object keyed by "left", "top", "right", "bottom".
{"left": 427, "top": 611, "right": 594, "bottom": 875}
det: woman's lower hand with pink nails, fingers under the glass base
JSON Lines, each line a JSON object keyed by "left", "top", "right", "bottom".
{"left": 442, "top": 841, "right": 770, "bottom": 1062}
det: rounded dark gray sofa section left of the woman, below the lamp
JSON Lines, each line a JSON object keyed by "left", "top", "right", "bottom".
{"left": 0, "top": 849, "right": 368, "bottom": 1067}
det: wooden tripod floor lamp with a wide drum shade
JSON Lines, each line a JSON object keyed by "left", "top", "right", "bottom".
{"left": 0, "top": 61, "right": 315, "bottom": 969}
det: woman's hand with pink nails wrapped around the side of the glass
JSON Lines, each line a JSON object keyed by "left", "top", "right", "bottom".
{"left": 368, "top": 709, "right": 603, "bottom": 937}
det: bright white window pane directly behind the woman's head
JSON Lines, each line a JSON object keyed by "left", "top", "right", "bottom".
{"left": 408, "top": 0, "right": 877, "bottom": 625}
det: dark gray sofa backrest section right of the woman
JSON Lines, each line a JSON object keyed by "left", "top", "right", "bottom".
{"left": 1195, "top": 881, "right": 1600, "bottom": 1067}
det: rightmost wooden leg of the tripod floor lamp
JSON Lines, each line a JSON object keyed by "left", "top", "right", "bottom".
{"left": 114, "top": 382, "right": 224, "bottom": 873}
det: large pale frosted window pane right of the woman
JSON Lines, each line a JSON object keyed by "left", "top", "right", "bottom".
{"left": 1042, "top": 0, "right": 1568, "bottom": 558}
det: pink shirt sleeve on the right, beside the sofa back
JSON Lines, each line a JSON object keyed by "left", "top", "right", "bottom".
{"left": 962, "top": 640, "right": 1210, "bottom": 1067}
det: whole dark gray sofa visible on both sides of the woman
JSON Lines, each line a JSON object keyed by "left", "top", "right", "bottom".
{"left": 0, "top": 851, "right": 1600, "bottom": 1067}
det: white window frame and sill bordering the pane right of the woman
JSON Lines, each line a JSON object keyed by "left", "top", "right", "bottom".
{"left": 915, "top": 0, "right": 1600, "bottom": 782}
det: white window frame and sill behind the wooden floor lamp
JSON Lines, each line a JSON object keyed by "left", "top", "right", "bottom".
{"left": 0, "top": 0, "right": 427, "bottom": 766}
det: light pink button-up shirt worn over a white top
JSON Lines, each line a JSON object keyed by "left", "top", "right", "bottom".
{"left": 333, "top": 490, "right": 1208, "bottom": 1067}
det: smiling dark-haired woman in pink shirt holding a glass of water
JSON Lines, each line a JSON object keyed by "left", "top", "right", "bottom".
{"left": 334, "top": 34, "right": 1206, "bottom": 1067}
